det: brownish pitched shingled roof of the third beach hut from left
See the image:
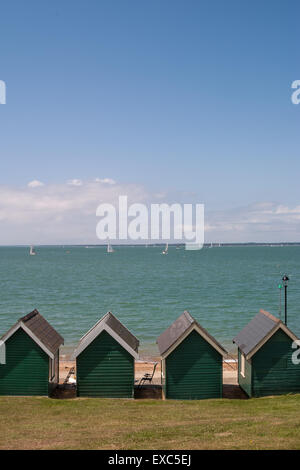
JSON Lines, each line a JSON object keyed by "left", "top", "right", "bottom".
{"left": 156, "top": 311, "right": 227, "bottom": 356}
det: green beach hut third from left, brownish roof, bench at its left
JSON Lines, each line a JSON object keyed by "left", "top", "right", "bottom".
{"left": 157, "top": 312, "right": 227, "bottom": 400}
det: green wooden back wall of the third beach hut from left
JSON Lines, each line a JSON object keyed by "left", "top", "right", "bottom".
{"left": 166, "top": 330, "right": 223, "bottom": 400}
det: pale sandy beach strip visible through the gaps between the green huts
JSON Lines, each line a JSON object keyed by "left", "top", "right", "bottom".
{"left": 59, "top": 358, "right": 237, "bottom": 385}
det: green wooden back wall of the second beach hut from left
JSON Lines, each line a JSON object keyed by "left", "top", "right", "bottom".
{"left": 76, "top": 331, "right": 134, "bottom": 398}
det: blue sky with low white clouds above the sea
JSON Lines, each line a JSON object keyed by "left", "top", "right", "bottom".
{"left": 0, "top": 0, "right": 300, "bottom": 244}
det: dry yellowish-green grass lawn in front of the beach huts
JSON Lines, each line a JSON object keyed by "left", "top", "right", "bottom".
{"left": 0, "top": 395, "right": 300, "bottom": 450}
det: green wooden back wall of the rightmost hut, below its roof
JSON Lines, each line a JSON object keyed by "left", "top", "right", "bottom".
{"left": 252, "top": 330, "right": 300, "bottom": 397}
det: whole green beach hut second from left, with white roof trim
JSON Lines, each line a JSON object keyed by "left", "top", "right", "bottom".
{"left": 73, "top": 312, "right": 139, "bottom": 398}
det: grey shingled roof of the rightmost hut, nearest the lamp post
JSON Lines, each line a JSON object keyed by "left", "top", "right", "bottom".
{"left": 233, "top": 310, "right": 297, "bottom": 356}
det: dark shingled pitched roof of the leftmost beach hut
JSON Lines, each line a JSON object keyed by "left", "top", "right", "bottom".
{"left": 1, "top": 310, "right": 64, "bottom": 357}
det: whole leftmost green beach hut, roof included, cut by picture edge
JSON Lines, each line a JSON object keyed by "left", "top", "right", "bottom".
{"left": 0, "top": 310, "right": 64, "bottom": 395}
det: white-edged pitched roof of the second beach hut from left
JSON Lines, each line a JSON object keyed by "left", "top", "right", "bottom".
{"left": 73, "top": 312, "right": 140, "bottom": 358}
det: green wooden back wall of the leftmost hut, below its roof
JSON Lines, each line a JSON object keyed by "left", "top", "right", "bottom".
{"left": 0, "top": 328, "right": 49, "bottom": 396}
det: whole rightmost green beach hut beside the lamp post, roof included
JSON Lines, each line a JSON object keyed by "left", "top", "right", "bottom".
{"left": 233, "top": 310, "right": 300, "bottom": 397}
